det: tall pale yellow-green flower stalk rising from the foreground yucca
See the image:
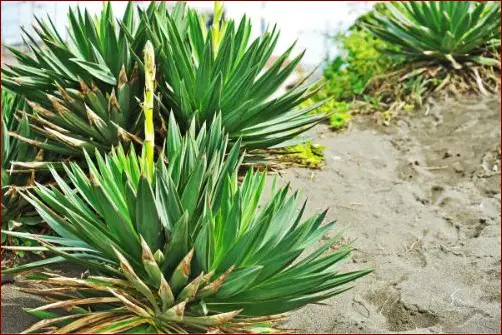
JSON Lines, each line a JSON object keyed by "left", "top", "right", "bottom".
{"left": 143, "top": 41, "right": 155, "bottom": 181}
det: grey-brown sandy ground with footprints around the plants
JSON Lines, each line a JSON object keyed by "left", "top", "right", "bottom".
{"left": 2, "top": 94, "right": 501, "bottom": 333}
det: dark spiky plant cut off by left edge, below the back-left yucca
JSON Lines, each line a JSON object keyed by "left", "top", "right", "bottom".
{"left": 2, "top": 89, "right": 41, "bottom": 243}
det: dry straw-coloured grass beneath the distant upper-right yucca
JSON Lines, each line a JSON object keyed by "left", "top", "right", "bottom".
{"left": 351, "top": 52, "right": 500, "bottom": 125}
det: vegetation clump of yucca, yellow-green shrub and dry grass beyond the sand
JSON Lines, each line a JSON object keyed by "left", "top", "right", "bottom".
{"left": 311, "top": 1, "right": 500, "bottom": 129}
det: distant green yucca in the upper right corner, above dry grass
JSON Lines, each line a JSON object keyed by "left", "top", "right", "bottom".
{"left": 366, "top": 1, "right": 500, "bottom": 69}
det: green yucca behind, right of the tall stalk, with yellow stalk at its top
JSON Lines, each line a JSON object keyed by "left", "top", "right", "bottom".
{"left": 131, "top": 2, "right": 326, "bottom": 149}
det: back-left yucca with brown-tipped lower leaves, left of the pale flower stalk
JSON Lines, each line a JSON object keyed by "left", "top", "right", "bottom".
{"left": 2, "top": 3, "right": 144, "bottom": 156}
